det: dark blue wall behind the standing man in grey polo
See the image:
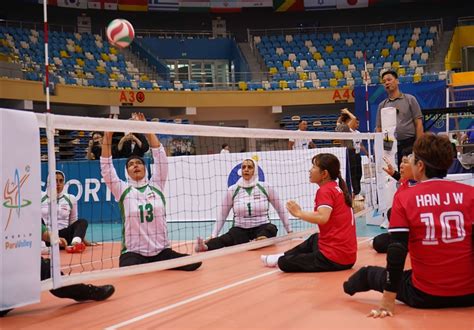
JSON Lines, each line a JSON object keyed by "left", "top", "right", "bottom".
{"left": 354, "top": 80, "right": 446, "bottom": 132}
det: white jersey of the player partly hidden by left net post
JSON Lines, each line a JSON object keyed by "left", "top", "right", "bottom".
{"left": 41, "top": 192, "right": 77, "bottom": 230}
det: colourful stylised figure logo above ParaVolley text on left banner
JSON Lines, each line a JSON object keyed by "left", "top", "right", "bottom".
{"left": 2, "top": 165, "right": 31, "bottom": 230}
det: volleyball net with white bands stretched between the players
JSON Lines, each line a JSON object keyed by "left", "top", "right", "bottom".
{"left": 31, "top": 114, "right": 386, "bottom": 289}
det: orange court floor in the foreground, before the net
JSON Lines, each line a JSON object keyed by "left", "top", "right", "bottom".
{"left": 0, "top": 239, "right": 474, "bottom": 330}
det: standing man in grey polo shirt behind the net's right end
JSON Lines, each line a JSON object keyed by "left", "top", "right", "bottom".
{"left": 375, "top": 70, "right": 423, "bottom": 166}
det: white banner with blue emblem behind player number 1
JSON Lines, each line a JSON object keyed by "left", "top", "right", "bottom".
{"left": 165, "top": 148, "right": 346, "bottom": 221}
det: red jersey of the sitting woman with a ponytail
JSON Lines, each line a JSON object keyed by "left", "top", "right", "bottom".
{"left": 314, "top": 181, "right": 357, "bottom": 265}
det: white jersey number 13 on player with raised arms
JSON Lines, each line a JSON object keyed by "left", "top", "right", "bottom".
{"left": 100, "top": 146, "right": 170, "bottom": 257}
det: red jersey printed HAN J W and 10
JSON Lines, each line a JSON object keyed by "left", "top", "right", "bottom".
{"left": 389, "top": 179, "right": 474, "bottom": 296}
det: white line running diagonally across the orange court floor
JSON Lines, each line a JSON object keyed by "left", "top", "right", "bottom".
{"left": 105, "top": 237, "right": 372, "bottom": 330}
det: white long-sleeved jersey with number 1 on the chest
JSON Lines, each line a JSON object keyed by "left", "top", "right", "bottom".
{"left": 212, "top": 182, "right": 291, "bottom": 237}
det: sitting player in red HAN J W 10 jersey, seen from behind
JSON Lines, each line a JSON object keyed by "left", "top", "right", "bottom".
{"left": 344, "top": 134, "right": 474, "bottom": 317}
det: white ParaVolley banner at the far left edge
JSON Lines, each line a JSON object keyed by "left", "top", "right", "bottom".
{"left": 0, "top": 109, "right": 41, "bottom": 310}
